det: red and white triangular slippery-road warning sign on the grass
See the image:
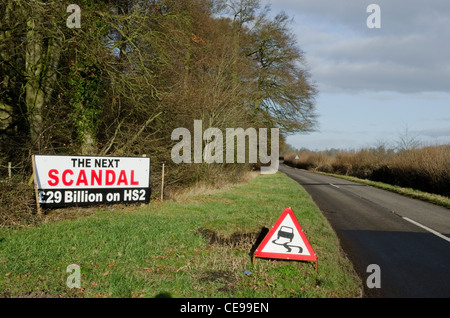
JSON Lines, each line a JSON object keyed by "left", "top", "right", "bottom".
{"left": 255, "top": 208, "right": 317, "bottom": 261}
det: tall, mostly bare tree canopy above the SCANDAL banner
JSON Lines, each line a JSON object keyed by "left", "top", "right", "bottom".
{"left": 0, "top": 0, "right": 317, "bottom": 186}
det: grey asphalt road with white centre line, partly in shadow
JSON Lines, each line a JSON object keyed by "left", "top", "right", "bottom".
{"left": 279, "top": 164, "right": 450, "bottom": 298}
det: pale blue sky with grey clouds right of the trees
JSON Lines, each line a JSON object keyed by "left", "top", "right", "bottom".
{"left": 263, "top": 0, "right": 450, "bottom": 150}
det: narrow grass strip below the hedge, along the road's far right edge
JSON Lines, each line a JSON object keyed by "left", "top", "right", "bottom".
{"left": 315, "top": 171, "right": 450, "bottom": 209}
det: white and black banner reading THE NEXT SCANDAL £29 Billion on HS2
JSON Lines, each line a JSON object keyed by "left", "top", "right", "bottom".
{"left": 33, "top": 155, "right": 150, "bottom": 208}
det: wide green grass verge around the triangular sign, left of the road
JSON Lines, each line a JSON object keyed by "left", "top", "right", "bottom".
{"left": 0, "top": 173, "right": 361, "bottom": 298}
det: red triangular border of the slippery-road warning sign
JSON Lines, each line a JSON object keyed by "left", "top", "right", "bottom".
{"left": 253, "top": 208, "right": 317, "bottom": 264}
